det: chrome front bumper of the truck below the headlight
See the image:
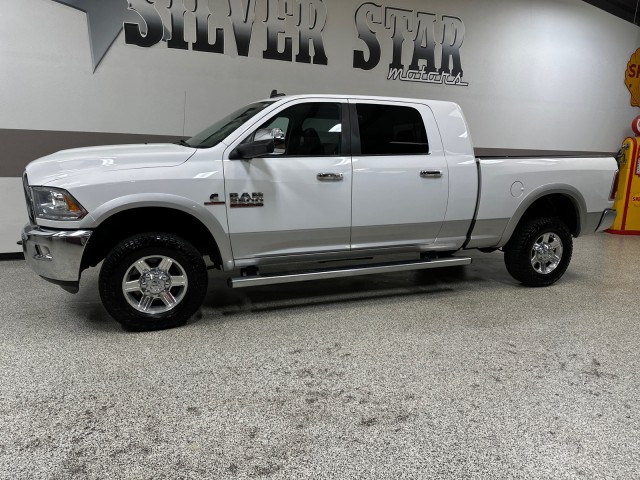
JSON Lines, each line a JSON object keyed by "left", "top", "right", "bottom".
{"left": 22, "top": 225, "right": 92, "bottom": 284}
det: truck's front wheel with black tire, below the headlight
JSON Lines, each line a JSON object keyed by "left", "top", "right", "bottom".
{"left": 99, "top": 233, "right": 208, "bottom": 331}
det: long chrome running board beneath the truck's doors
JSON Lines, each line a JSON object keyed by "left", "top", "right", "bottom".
{"left": 227, "top": 257, "right": 471, "bottom": 288}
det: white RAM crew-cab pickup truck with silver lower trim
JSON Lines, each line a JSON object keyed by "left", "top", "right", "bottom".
{"left": 22, "top": 95, "right": 617, "bottom": 330}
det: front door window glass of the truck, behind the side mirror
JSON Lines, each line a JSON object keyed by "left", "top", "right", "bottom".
{"left": 245, "top": 103, "right": 342, "bottom": 157}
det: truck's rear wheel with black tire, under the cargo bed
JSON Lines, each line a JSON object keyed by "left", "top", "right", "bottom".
{"left": 504, "top": 218, "right": 573, "bottom": 287}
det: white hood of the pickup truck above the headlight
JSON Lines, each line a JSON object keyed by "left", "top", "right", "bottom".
{"left": 27, "top": 143, "right": 196, "bottom": 185}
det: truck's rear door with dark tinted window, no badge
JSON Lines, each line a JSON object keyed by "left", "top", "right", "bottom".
{"left": 350, "top": 99, "right": 449, "bottom": 248}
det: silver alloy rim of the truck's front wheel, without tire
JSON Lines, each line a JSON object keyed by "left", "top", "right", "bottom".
{"left": 122, "top": 255, "right": 189, "bottom": 315}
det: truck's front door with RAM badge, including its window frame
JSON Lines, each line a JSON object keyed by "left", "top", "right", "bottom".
{"left": 224, "top": 98, "right": 351, "bottom": 260}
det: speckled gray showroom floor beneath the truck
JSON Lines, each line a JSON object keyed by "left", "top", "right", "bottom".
{"left": 0, "top": 234, "right": 640, "bottom": 479}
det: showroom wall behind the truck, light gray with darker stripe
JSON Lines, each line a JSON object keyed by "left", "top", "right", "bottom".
{"left": 0, "top": 0, "right": 640, "bottom": 253}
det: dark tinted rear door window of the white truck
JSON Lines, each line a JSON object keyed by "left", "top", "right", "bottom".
{"left": 356, "top": 103, "right": 429, "bottom": 155}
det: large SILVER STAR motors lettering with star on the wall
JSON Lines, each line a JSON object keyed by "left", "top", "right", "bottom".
{"left": 48, "top": 0, "right": 468, "bottom": 86}
